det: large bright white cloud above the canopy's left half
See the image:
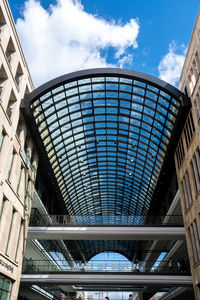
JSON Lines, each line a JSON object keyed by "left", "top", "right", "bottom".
{"left": 16, "top": 0, "right": 139, "bottom": 86}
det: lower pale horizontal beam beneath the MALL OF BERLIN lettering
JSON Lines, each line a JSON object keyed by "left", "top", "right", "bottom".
{"left": 21, "top": 272, "right": 192, "bottom": 287}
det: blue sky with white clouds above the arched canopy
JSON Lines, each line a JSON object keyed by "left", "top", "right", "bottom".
{"left": 9, "top": 0, "right": 200, "bottom": 87}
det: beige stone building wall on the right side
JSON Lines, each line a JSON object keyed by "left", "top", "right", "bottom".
{"left": 175, "top": 7, "right": 200, "bottom": 299}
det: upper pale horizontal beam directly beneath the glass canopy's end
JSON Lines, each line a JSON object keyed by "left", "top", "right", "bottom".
{"left": 28, "top": 226, "right": 185, "bottom": 240}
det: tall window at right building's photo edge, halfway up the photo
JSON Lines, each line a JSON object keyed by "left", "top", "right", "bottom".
{"left": 190, "top": 148, "right": 200, "bottom": 194}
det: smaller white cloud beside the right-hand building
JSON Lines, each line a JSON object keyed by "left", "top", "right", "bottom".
{"left": 158, "top": 41, "right": 187, "bottom": 85}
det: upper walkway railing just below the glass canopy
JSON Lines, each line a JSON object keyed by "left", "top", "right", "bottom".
{"left": 29, "top": 210, "right": 183, "bottom": 226}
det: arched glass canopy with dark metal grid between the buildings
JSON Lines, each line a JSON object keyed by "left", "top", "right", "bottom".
{"left": 21, "top": 69, "right": 190, "bottom": 216}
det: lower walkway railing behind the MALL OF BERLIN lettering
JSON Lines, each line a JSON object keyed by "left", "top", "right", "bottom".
{"left": 22, "top": 259, "right": 189, "bottom": 274}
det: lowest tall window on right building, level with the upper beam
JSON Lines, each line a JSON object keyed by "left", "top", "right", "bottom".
{"left": 188, "top": 220, "right": 200, "bottom": 264}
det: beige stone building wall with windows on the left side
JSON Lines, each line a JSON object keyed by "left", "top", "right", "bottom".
{"left": 0, "top": 0, "right": 37, "bottom": 299}
